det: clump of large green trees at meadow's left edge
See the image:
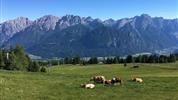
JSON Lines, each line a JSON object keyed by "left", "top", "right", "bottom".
{"left": 0, "top": 45, "right": 46, "bottom": 72}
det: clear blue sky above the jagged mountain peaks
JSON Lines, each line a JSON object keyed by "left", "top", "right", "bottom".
{"left": 0, "top": 0, "right": 178, "bottom": 22}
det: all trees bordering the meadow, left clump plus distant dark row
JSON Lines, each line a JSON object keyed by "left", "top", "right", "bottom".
{"left": 0, "top": 45, "right": 178, "bottom": 72}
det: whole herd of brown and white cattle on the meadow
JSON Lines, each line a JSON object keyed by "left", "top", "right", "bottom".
{"left": 80, "top": 76, "right": 143, "bottom": 89}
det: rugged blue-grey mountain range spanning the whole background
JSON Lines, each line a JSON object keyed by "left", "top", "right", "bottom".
{"left": 0, "top": 14, "right": 178, "bottom": 58}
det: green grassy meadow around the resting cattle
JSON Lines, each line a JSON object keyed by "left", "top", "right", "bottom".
{"left": 0, "top": 63, "right": 178, "bottom": 100}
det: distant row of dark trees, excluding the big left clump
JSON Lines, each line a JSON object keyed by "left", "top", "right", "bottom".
{"left": 39, "top": 54, "right": 178, "bottom": 66}
